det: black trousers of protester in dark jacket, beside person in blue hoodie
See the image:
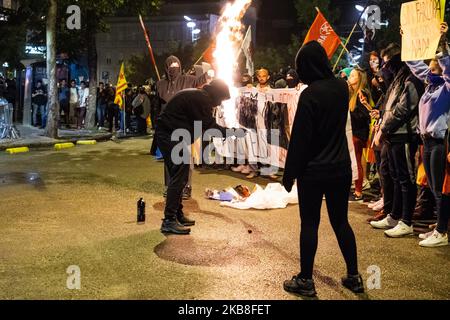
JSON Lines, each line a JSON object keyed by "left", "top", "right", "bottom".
{"left": 384, "top": 142, "right": 418, "bottom": 225}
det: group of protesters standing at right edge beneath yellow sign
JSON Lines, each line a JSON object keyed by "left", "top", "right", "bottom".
{"left": 339, "top": 23, "right": 450, "bottom": 247}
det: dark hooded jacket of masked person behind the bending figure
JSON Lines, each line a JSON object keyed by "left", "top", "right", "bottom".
{"left": 156, "top": 56, "right": 208, "bottom": 107}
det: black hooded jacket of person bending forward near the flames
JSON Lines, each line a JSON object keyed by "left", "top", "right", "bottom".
{"left": 156, "top": 80, "right": 230, "bottom": 143}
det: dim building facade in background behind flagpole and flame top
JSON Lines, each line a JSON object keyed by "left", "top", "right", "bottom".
{"left": 97, "top": 0, "right": 258, "bottom": 83}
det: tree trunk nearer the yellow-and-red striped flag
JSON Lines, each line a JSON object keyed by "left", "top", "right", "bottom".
{"left": 85, "top": 16, "right": 97, "bottom": 129}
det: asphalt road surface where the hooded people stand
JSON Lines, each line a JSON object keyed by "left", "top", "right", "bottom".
{"left": 0, "top": 139, "right": 450, "bottom": 300}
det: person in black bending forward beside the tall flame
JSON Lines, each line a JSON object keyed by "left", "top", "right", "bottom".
{"left": 155, "top": 80, "right": 239, "bottom": 235}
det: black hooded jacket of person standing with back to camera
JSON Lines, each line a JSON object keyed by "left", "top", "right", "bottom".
{"left": 284, "top": 41, "right": 352, "bottom": 181}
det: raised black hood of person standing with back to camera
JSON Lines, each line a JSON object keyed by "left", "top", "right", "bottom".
{"left": 295, "top": 41, "right": 334, "bottom": 85}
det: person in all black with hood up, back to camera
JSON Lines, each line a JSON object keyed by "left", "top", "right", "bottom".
{"left": 283, "top": 41, "right": 364, "bottom": 296}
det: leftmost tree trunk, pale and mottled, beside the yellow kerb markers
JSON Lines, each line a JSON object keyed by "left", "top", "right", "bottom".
{"left": 45, "top": 0, "right": 59, "bottom": 139}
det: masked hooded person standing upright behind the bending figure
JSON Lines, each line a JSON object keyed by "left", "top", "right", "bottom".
{"left": 150, "top": 56, "right": 211, "bottom": 199}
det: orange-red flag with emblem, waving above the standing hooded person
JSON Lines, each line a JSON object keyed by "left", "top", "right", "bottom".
{"left": 303, "top": 12, "right": 341, "bottom": 59}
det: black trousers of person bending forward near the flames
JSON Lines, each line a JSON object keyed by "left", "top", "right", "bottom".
{"left": 155, "top": 129, "right": 190, "bottom": 221}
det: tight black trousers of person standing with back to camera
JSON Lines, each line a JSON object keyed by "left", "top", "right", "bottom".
{"left": 298, "top": 176, "right": 358, "bottom": 279}
